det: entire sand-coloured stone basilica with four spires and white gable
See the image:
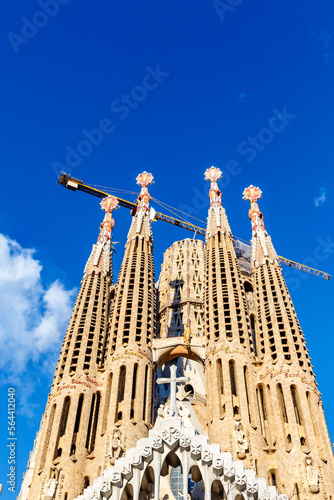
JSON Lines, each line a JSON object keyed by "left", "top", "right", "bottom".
{"left": 19, "top": 167, "right": 334, "bottom": 500}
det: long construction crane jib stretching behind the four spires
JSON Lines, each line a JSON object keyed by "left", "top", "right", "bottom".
{"left": 58, "top": 172, "right": 331, "bottom": 280}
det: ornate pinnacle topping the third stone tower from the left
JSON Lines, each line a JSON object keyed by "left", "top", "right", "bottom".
{"left": 204, "top": 167, "right": 232, "bottom": 240}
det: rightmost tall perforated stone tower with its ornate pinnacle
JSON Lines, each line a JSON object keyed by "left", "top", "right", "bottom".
{"left": 243, "top": 186, "right": 334, "bottom": 499}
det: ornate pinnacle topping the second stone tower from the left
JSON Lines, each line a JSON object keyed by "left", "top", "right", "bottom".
{"left": 127, "top": 171, "right": 154, "bottom": 244}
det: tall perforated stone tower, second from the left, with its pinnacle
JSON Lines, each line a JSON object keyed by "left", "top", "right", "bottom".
{"left": 102, "top": 172, "right": 156, "bottom": 454}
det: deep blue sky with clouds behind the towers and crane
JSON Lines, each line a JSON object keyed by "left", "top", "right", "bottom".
{"left": 0, "top": 0, "right": 334, "bottom": 499}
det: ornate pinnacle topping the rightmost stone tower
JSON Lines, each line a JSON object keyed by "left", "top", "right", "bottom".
{"left": 243, "top": 185, "right": 278, "bottom": 267}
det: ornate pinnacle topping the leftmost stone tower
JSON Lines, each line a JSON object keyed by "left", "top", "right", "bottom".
{"left": 84, "top": 196, "right": 119, "bottom": 276}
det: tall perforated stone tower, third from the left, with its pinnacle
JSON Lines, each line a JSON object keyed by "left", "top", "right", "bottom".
{"left": 204, "top": 167, "right": 259, "bottom": 468}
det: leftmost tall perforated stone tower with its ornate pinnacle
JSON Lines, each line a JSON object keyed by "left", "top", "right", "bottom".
{"left": 22, "top": 196, "right": 118, "bottom": 500}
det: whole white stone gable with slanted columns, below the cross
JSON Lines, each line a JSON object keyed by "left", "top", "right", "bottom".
{"left": 76, "top": 416, "right": 287, "bottom": 500}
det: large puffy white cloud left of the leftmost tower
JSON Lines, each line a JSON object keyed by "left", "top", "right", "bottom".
{"left": 0, "top": 234, "right": 75, "bottom": 378}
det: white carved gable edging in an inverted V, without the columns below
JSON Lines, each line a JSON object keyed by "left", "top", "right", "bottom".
{"left": 73, "top": 415, "right": 288, "bottom": 500}
